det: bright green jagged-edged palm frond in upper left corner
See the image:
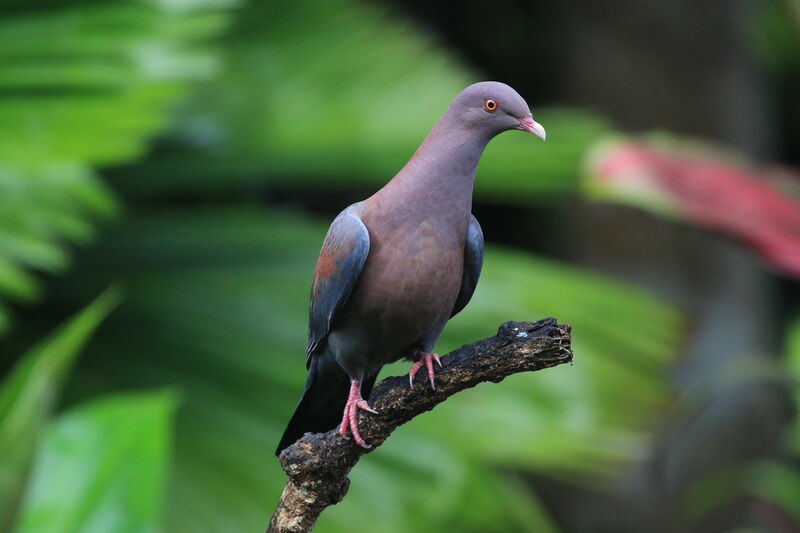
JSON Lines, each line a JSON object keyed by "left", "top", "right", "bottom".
{"left": 0, "top": 0, "right": 231, "bottom": 334}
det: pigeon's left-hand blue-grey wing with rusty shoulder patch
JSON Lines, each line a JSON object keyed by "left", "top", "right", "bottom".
{"left": 306, "top": 204, "right": 369, "bottom": 364}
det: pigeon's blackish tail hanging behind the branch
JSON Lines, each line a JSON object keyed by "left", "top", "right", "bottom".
{"left": 275, "top": 354, "right": 375, "bottom": 455}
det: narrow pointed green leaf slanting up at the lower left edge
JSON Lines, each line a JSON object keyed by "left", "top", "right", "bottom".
{"left": 0, "top": 289, "right": 120, "bottom": 531}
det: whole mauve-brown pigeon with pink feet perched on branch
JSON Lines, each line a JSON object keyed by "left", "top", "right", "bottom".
{"left": 276, "top": 81, "right": 545, "bottom": 455}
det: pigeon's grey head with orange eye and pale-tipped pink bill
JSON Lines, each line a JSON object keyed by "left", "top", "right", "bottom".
{"left": 449, "top": 81, "right": 546, "bottom": 140}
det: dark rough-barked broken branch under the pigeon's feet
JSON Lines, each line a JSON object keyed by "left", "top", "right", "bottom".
{"left": 267, "top": 318, "right": 572, "bottom": 533}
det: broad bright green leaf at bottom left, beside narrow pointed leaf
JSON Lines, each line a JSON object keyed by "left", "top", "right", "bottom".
{"left": 15, "top": 393, "right": 175, "bottom": 533}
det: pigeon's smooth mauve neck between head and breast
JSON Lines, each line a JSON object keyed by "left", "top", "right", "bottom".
{"left": 385, "top": 118, "right": 492, "bottom": 213}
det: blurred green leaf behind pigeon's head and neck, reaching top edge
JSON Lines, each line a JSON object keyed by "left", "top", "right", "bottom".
{"left": 115, "top": 0, "right": 607, "bottom": 203}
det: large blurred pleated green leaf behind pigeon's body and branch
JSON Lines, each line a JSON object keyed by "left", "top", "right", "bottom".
{"left": 31, "top": 206, "right": 681, "bottom": 532}
